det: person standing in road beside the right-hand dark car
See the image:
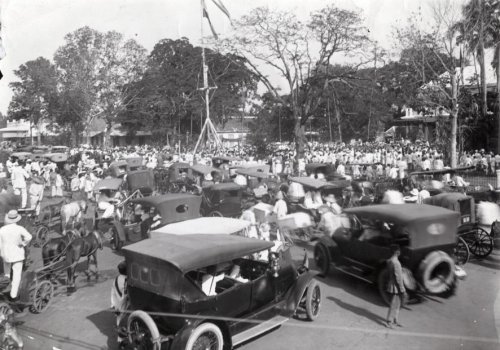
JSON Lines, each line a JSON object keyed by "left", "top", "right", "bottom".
{"left": 385, "top": 244, "right": 406, "bottom": 328}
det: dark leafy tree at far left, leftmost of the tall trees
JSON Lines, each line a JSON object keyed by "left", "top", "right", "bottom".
{"left": 7, "top": 57, "right": 57, "bottom": 145}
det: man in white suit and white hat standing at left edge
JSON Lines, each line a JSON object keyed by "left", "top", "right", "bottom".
{"left": 0, "top": 210, "right": 32, "bottom": 300}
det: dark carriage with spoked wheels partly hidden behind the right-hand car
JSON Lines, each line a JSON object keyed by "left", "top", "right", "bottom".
{"left": 424, "top": 192, "right": 493, "bottom": 265}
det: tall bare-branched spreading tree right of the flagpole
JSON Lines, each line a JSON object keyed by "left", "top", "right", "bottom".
{"left": 219, "top": 6, "right": 368, "bottom": 170}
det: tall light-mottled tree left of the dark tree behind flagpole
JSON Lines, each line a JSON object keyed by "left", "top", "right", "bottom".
{"left": 54, "top": 27, "right": 146, "bottom": 143}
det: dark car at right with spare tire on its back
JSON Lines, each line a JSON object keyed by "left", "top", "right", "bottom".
{"left": 314, "top": 204, "right": 459, "bottom": 302}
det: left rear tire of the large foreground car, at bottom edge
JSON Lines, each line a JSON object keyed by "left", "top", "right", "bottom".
{"left": 127, "top": 310, "right": 161, "bottom": 350}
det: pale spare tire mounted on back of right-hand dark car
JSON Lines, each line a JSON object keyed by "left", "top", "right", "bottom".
{"left": 418, "top": 250, "right": 455, "bottom": 294}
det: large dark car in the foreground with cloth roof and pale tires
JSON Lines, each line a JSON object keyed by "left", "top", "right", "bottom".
{"left": 124, "top": 232, "right": 321, "bottom": 350}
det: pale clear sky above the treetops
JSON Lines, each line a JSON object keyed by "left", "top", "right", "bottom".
{"left": 0, "top": 0, "right": 431, "bottom": 114}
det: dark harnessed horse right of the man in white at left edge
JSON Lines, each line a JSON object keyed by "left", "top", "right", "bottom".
{"left": 66, "top": 231, "right": 103, "bottom": 293}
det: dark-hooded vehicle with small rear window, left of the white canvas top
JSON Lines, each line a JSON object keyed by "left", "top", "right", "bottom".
{"left": 106, "top": 193, "right": 201, "bottom": 250}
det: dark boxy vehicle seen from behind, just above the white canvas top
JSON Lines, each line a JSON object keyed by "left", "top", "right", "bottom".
{"left": 201, "top": 182, "right": 243, "bottom": 217}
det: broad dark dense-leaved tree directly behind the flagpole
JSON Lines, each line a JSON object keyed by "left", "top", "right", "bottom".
{"left": 120, "top": 38, "right": 257, "bottom": 145}
